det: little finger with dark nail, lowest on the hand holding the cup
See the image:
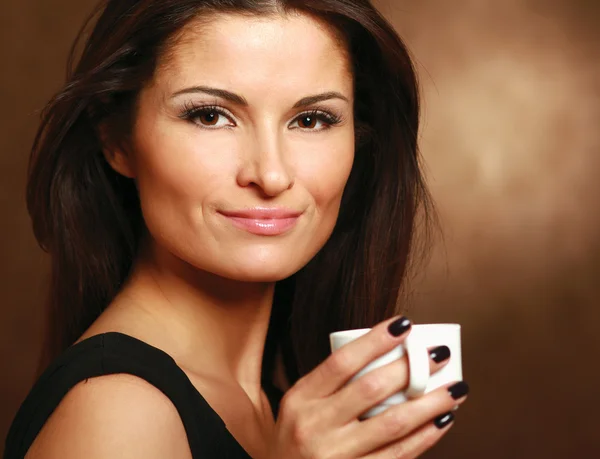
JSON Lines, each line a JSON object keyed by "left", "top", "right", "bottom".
{"left": 361, "top": 412, "right": 454, "bottom": 459}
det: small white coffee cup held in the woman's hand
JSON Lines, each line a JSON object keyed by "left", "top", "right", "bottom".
{"left": 329, "top": 324, "right": 463, "bottom": 419}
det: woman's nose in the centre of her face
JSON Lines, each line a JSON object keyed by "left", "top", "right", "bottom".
{"left": 237, "top": 130, "right": 294, "bottom": 197}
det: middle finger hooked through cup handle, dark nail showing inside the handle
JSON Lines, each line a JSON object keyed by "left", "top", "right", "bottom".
{"left": 321, "top": 346, "right": 450, "bottom": 424}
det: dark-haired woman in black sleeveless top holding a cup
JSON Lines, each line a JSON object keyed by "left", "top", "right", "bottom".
{"left": 5, "top": 0, "right": 466, "bottom": 459}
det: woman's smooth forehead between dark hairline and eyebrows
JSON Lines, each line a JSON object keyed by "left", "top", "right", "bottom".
{"left": 155, "top": 13, "right": 352, "bottom": 96}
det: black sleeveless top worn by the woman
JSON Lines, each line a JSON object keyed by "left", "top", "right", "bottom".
{"left": 4, "top": 332, "right": 282, "bottom": 459}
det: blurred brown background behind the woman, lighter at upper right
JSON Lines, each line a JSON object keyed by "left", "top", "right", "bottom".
{"left": 0, "top": 0, "right": 600, "bottom": 459}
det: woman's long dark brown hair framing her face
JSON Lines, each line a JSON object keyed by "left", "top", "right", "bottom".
{"left": 27, "top": 0, "right": 429, "bottom": 383}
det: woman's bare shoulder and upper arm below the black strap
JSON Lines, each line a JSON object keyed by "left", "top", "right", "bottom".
{"left": 26, "top": 374, "right": 191, "bottom": 459}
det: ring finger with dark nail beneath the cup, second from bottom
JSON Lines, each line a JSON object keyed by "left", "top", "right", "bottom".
{"left": 347, "top": 382, "right": 469, "bottom": 455}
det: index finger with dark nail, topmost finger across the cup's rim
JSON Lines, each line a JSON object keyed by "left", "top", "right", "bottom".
{"left": 294, "top": 316, "right": 412, "bottom": 398}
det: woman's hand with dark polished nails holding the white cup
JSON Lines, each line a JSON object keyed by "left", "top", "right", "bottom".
{"left": 269, "top": 317, "right": 468, "bottom": 459}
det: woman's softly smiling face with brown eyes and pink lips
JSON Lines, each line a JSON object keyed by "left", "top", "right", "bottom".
{"left": 113, "top": 15, "right": 354, "bottom": 281}
